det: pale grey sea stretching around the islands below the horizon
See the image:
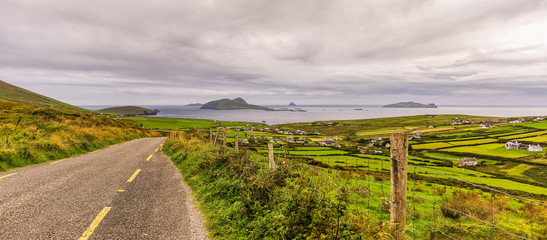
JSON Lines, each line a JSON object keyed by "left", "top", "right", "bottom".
{"left": 81, "top": 105, "right": 547, "bottom": 125}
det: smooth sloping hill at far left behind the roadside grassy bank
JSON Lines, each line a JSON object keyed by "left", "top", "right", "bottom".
{"left": 0, "top": 80, "right": 90, "bottom": 112}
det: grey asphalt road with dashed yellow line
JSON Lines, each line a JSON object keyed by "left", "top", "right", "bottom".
{"left": 0, "top": 138, "right": 208, "bottom": 239}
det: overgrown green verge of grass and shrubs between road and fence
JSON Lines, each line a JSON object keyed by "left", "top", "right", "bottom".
{"left": 163, "top": 130, "right": 390, "bottom": 239}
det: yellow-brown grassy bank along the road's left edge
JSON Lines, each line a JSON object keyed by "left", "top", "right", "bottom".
{"left": 0, "top": 102, "right": 159, "bottom": 171}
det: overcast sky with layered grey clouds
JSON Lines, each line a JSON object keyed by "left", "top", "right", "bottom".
{"left": 0, "top": 0, "right": 547, "bottom": 105}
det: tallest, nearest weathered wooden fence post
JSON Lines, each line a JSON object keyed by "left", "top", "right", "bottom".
{"left": 390, "top": 133, "right": 408, "bottom": 240}
